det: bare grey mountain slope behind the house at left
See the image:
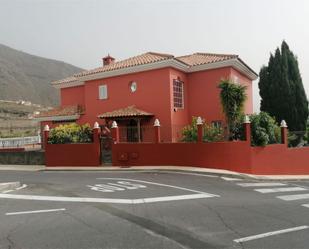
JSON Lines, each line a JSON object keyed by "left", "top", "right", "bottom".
{"left": 0, "top": 44, "right": 82, "bottom": 106}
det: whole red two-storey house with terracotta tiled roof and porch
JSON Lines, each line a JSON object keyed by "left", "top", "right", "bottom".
{"left": 38, "top": 52, "right": 257, "bottom": 142}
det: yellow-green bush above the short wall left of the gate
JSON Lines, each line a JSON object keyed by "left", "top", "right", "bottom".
{"left": 48, "top": 123, "right": 92, "bottom": 144}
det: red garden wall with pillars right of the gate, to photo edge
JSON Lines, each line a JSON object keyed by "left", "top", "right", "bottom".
{"left": 112, "top": 123, "right": 309, "bottom": 175}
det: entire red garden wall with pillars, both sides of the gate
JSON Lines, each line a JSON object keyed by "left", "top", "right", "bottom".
{"left": 44, "top": 123, "right": 309, "bottom": 175}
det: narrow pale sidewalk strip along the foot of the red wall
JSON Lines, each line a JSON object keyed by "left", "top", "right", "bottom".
{"left": 0, "top": 165, "right": 309, "bottom": 180}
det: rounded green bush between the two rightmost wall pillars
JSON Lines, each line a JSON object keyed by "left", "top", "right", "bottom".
{"left": 250, "top": 112, "right": 281, "bottom": 146}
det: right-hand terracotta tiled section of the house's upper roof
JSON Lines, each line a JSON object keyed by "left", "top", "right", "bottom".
{"left": 176, "top": 53, "right": 238, "bottom": 66}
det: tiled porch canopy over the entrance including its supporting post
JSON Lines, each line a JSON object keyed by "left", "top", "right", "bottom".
{"left": 98, "top": 105, "right": 154, "bottom": 142}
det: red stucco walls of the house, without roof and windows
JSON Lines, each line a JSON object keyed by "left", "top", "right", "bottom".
{"left": 57, "top": 64, "right": 253, "bottom": 141}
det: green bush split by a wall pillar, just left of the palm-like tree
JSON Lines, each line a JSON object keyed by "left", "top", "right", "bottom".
{"left": 181, "top": 117, "right": 223, "bottom": 142}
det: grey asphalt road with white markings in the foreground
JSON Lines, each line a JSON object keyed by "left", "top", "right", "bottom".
{"left": 0, "top": 171, "right": 309, "bottom": 249}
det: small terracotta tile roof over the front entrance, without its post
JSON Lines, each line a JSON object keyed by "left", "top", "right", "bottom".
{"left": 98, "top": 105, "right": 153, "bottom": 118}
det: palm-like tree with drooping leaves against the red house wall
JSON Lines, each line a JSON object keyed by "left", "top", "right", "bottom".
{"left": 219, "top": 80, "right": 247, "bottom": 140}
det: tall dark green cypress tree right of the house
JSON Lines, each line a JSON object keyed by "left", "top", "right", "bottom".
{"left": 259, "top": 41, "right": 308, "bottom": 131}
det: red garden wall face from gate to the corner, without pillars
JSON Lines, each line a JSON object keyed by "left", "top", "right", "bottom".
{"left": 112, "top": 142, "right": 251, "bottom": 173}
